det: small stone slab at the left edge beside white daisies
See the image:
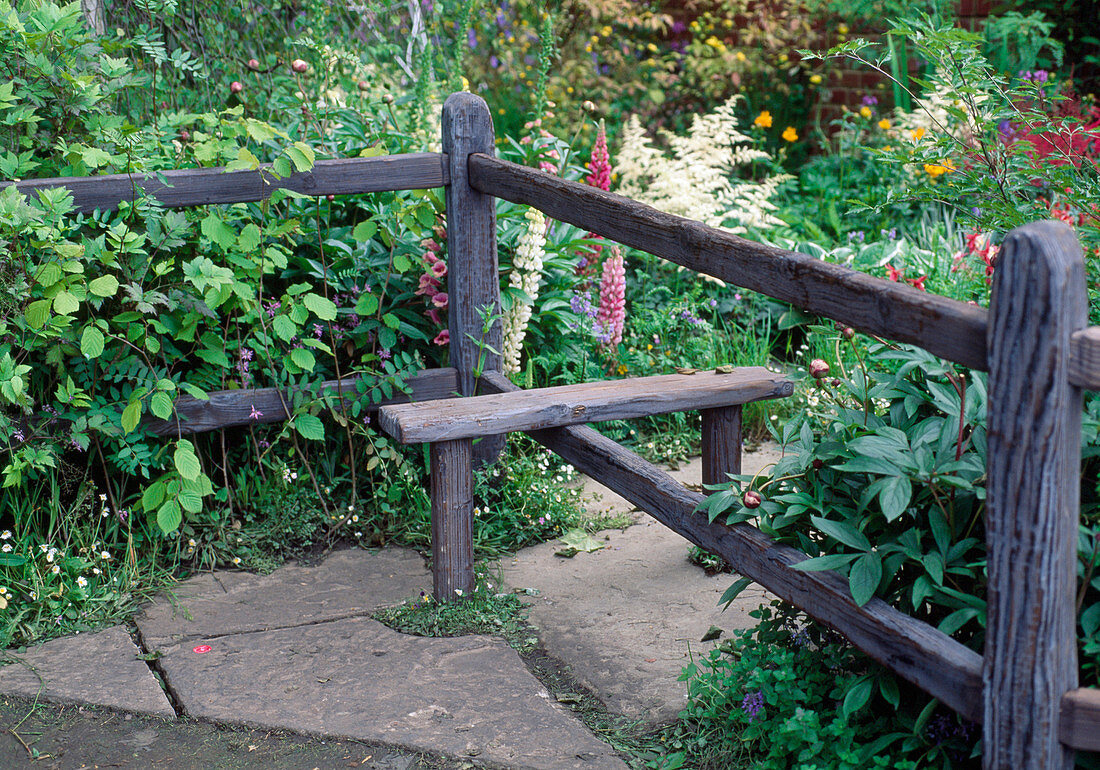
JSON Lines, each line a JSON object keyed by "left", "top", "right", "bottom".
{"left": 0, "top": 626, "right": 176, "bottom": 719}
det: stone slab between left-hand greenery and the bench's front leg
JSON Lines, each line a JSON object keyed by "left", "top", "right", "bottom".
{"left": 135, "top": 548, "right": 431, "bottom": 650}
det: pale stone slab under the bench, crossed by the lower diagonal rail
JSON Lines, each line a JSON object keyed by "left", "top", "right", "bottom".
{"left": 502, "top": 444, "right": 781, "bottom": 723}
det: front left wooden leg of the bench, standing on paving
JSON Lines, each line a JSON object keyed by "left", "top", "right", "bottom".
{"left": 430, "top": 439, "right": 474, "bottom": 602}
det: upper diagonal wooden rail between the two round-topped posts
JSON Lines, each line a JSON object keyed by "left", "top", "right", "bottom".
{"left": 470, "top": 155, "right": 987, "bottom": 370}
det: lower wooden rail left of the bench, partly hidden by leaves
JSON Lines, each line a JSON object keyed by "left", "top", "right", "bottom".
{"left": 142, "top": 369, "right": 459, "bottom": 436}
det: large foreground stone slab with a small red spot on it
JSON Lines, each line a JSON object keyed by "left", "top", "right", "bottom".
{"left": 160, "top": 611, "right": 626, "bottom": 770}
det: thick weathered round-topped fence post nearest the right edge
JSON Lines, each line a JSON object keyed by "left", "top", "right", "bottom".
{"left": 982, "top": 221, "right": 1087, "bottom": 770}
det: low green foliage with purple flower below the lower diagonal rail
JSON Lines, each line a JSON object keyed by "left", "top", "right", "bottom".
{"left": 660, "top": 602, "right": 976, "bottom": 770}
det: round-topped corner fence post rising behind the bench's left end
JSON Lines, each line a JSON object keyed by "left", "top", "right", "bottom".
{"left": 443, "top": 91, "right": 504, "bottom": 465}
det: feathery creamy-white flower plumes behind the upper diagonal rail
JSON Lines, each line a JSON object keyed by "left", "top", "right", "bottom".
{"left": 616, "top": 96, "right": 790, "bottom": 232}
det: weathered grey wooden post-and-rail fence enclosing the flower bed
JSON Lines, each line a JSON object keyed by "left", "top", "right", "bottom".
{"left": 8, "top": 94, "right": 1100, "bottom": 770}
